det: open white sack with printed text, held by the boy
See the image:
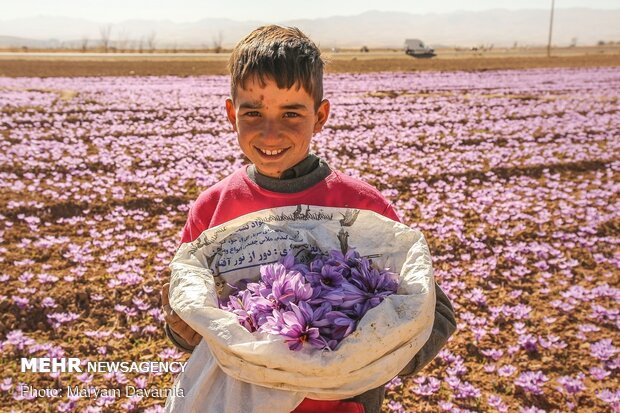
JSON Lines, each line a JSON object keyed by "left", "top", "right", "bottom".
{"left": 166, "top": 205, "right": 435, "bottom": 413}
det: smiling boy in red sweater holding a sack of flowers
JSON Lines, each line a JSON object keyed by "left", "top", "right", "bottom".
{"left": 162, "top": 26, "right": 456, "bottom": 413}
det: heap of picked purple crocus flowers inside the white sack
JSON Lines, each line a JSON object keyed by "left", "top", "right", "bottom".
{"left": 220, "top": 250, "right": 398, "bottom": 351}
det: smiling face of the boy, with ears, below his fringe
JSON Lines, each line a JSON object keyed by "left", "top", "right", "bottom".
{"left": 226, "top": 77, "right": 329, "bottom": 178}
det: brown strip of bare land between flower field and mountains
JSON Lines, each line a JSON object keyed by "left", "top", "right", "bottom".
{"left": 0, "top": 48, "right": 620, "bottom": 77}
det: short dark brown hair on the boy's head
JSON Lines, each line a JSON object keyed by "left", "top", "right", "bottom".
{"left": 228, "top": 25, "right": 324, "bottom": 110}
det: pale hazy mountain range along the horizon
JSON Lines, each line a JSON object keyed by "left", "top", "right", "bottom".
{"left": 0, "top": 8, "right": 620, "bottom": 49}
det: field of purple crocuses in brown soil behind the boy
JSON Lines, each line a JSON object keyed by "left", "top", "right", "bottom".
{"left": 0, "top": 68, "right": 620, "bottom": 413}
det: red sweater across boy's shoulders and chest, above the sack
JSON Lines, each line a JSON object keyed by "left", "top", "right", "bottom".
{"left": 181, "top": 166, "right": 400, "bottom": 242}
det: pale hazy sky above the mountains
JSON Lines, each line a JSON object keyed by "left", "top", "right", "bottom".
{"left": 0, "top": 0, "right": 620, "bottom": 23}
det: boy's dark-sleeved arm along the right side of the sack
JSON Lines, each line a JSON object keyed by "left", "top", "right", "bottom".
{"left": 398, "top": 283, "right": 456, "bottom": 376}
